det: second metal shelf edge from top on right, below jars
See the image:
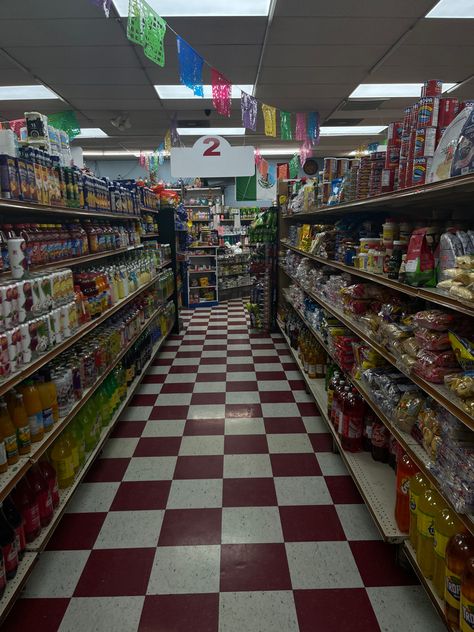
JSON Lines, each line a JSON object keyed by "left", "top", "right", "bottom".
{"left": 280, "top": 239, "right": 474, "bottom": 316}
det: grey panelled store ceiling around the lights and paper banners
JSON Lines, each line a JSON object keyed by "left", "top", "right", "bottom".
{"left": 0, "top": 0, "right": 474, "bottom": 155}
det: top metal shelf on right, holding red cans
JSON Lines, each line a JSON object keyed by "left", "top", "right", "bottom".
{"left": 281, "top": 175, "right": 474, "bottom": 220}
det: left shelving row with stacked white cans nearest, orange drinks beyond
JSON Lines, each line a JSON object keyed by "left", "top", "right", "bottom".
{"left": 0, "top": 249, "right": 174, "bottom": 379}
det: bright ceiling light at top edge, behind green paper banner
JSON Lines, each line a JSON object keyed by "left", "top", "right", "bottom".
{"left": 113, "top": 0, "right": 270, "bottom": 18}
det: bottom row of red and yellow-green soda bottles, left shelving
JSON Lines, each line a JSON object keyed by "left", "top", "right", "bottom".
{"left": 0, "top": 305, "right": 175, "bottom": 596}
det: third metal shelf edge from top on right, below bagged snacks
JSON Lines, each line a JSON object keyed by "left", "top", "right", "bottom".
{"left": 282, "top": 268, "right": 474, "bottom": 430}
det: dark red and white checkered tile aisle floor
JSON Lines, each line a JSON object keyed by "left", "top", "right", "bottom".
{"left": 2, "top": 301, "right": 444, "bottom": 632}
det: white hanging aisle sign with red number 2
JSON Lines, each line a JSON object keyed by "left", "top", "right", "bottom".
{"left": 170, "top": 136, "right": 255, "bottom": 178}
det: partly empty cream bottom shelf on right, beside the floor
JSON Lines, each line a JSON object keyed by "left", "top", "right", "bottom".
{"left": 277, "top": 321, "right": 408, "bottom": 542}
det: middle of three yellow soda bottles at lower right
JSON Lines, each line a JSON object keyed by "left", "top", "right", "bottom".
{"left": 416, "top": 488, "right": 444, "bottom": 579}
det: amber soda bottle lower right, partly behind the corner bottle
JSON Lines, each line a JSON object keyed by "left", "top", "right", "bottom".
{"left": 444, "top": 533, "right": 474, "bottom": 630}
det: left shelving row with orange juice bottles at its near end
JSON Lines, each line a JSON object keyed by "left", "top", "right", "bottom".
{"left": 0, "top": 288, "right": 174, "bottom": 464}
